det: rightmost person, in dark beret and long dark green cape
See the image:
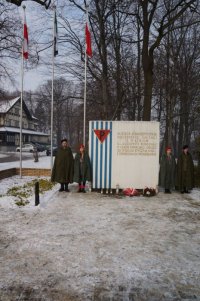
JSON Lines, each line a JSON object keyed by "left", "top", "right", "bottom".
{"left": 176, "top": 145, "right": 194, "bottom": 193}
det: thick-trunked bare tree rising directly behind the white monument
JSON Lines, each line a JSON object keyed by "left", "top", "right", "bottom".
{"left": 138, "top": 0, "right": 196, "bottom": 121}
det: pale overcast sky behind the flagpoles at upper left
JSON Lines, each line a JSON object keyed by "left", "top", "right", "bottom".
{"left": 4, "top": 0, "right": 84, "bottom": 91}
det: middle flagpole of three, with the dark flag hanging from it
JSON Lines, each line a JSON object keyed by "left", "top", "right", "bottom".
{"left": 51, "top": 5, "right": 56, "bottom": 171}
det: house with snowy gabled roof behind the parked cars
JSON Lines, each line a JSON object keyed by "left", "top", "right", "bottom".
{"left": 0, "top": 97, "right": 50, "bottom": 151}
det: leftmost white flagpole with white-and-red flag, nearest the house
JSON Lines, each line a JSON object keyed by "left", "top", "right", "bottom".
{"left": 19, "top": 5, "right": 26, "bottom": 178}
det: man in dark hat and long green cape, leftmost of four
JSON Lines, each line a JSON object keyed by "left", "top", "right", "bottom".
{"left": 51, "top": 139, "right": 74, "bottom": 192}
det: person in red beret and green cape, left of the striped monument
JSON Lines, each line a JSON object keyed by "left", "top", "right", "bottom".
{"left": 74, "top": 144, "right": 91, "bottom": 192}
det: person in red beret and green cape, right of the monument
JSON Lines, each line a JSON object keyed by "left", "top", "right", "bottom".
{"left": 159, "top": 146, "right": 176, "bottom": 193}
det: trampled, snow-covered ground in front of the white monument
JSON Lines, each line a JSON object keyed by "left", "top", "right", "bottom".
{"left": 0, "top": 157, "right": 200, "bottom": 301}
